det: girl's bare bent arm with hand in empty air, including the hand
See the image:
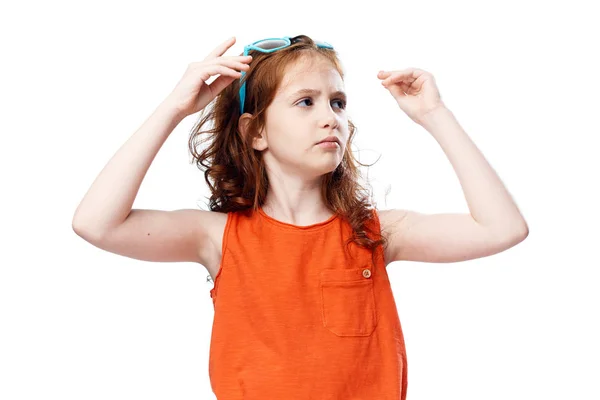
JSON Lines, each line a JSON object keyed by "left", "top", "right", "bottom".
{"left": 378, "top": 68, "right": 529, "bottom": 263}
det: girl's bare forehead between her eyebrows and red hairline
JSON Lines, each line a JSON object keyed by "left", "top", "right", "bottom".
{"left": 279, "top": 56, "right": 344, "bottom": 95}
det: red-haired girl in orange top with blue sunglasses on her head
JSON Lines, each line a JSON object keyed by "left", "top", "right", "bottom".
{"left": 73, "top": 35, "right": 528, "bottom": 400}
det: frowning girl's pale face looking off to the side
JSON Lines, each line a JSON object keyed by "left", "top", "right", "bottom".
{"left": 254, "top": 58, "right": 349, "bottom": 180}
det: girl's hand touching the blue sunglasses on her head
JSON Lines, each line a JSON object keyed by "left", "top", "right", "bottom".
{"left": 165, "top": 37, "right": 252, "bottom": 117}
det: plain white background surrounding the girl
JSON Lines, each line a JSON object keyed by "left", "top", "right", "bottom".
{"left": 0, "top": 0, "right": 600, "bottom": 400}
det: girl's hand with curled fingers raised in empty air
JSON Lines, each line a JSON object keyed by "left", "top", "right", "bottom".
{"left": 377, "top": 68, "right": 445, "bottom": 124}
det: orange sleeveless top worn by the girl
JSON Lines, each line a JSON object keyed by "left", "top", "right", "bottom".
{"left": 209, "top": 209, "right": 407, "bottom": 400}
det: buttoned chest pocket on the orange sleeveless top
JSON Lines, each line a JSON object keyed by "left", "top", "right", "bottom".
{"left": 320, "top": 267, "right": 377, "bottom": 336}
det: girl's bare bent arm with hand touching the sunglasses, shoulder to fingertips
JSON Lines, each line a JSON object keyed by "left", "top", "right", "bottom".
{"left": 72, "top": 38, "right": 251, "bottom": 266}
